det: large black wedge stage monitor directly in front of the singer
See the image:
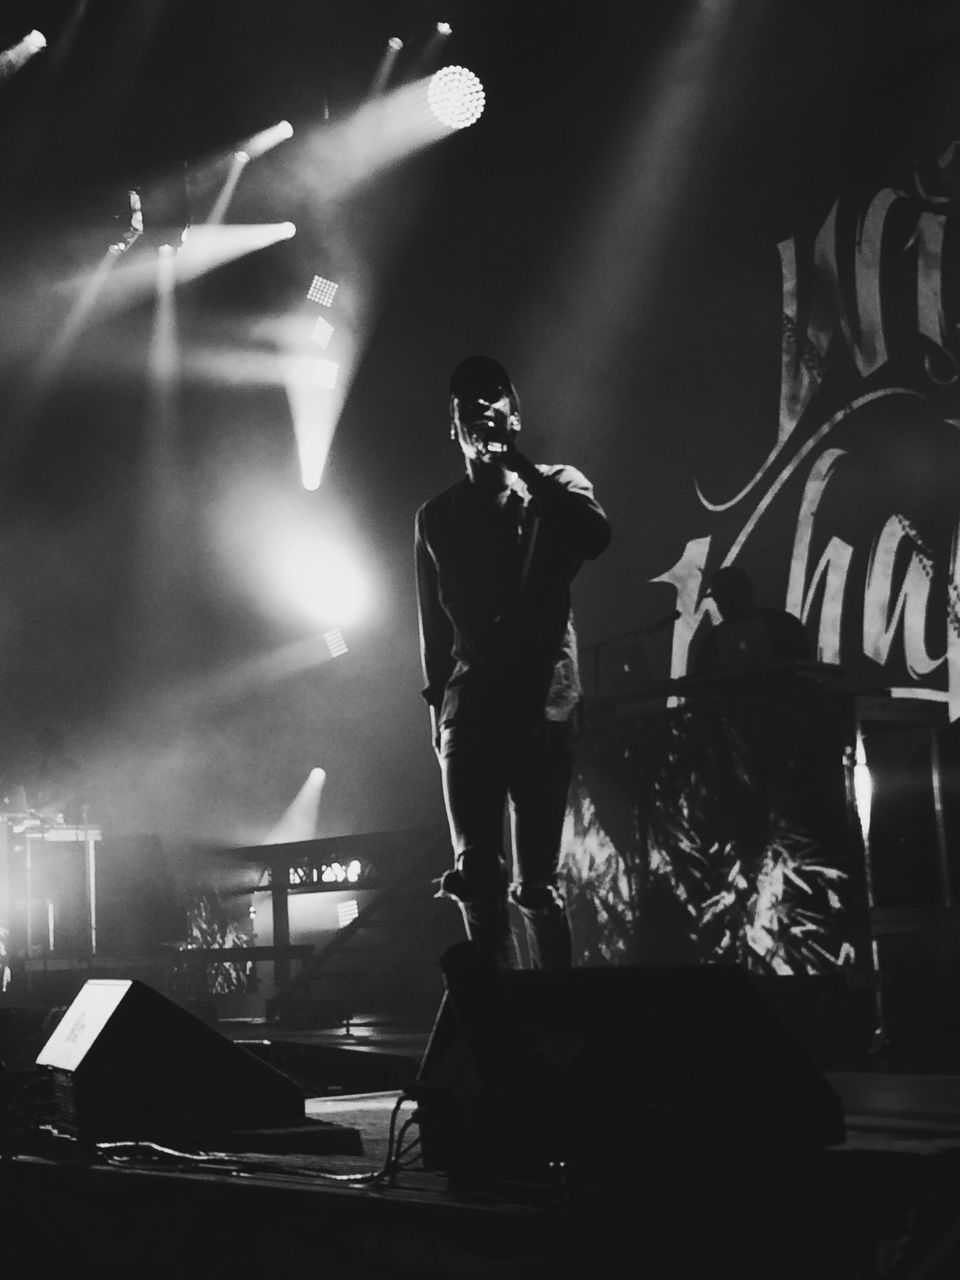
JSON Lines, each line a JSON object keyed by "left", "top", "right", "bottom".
{"left": 410, "top": 942, "right": 845, "bottom": 1176}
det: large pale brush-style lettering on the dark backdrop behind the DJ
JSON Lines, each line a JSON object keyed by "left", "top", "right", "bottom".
{"left": 653, "top": 162, "right": 960, "bottom": 719}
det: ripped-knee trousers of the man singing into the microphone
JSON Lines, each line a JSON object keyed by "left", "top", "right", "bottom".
{"left": 439, "top": 722, "right": 573, "bottom": 969}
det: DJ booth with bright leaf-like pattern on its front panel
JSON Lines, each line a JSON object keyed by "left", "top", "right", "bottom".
{"left": 564, "top": 662, "right": 960, "bottom": 1054}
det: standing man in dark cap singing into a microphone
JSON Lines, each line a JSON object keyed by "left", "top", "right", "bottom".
{"left": 416, "top": 356, "right": 611, "bottom": 969}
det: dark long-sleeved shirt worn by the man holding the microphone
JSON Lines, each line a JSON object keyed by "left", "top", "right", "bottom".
{"left": 416, "top": 465, "right": 611, "bottom": 733}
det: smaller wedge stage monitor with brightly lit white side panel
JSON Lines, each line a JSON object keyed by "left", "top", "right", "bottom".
{"left": 36, "top": 979, "right": 306, "bottom": 1143}
